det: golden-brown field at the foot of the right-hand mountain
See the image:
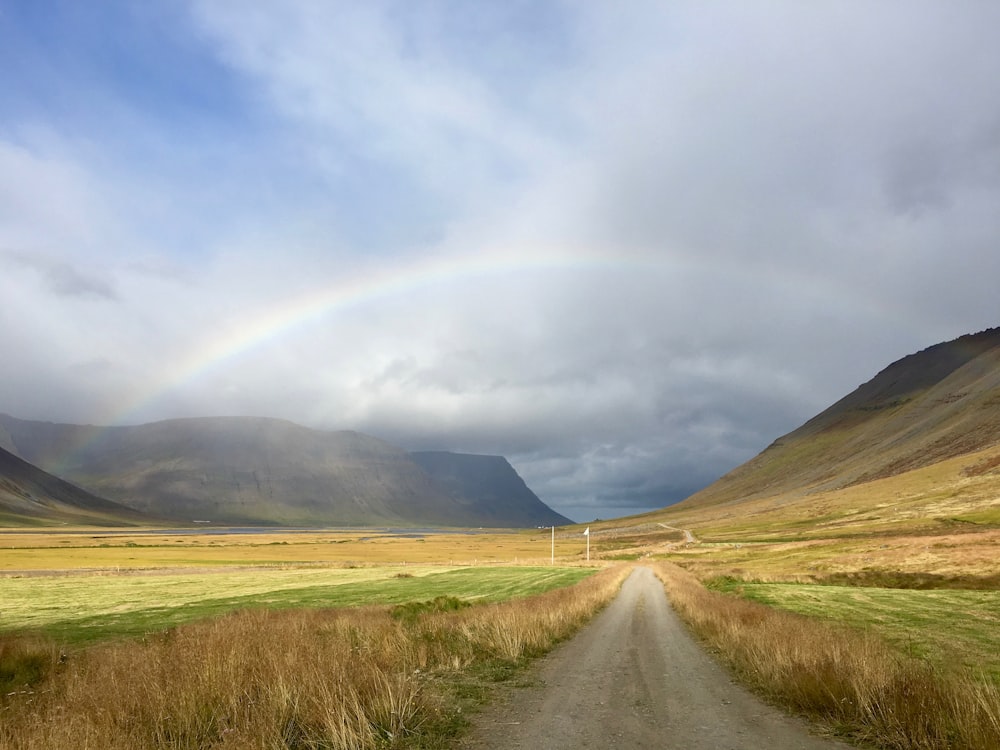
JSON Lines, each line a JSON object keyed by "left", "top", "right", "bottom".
{"left": 591, "top": 447, "right": 1000, "bottom": 588}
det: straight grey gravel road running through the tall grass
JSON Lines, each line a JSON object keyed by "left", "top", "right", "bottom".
{"left": 459, "top": 568, "right": 848, "bottom": 750}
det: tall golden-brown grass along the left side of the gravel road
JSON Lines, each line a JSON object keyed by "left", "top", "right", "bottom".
{"left": 0, "top": 569, "right": 625, "bottom": 750}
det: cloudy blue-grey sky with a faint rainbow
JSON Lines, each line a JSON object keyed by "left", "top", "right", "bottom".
{"left": 0, "top": 0, "right": 1000, "bottom": 520}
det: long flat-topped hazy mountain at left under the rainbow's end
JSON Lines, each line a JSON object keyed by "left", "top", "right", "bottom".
{"left": 0, "top": 415, "right": 564, "bottom": 526}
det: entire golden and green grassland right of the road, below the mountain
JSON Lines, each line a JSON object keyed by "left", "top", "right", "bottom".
{"left": 591, "top": 464, "right": 1000, "bottom": 750}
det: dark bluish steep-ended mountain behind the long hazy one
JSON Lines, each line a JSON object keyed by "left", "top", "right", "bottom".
{"left": 410, "top": 451, "right": 573, "bottom": 526}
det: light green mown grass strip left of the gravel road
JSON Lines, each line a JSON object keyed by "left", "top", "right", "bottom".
{"left": 0, "top": 566, "right": 593, "bottom": 644}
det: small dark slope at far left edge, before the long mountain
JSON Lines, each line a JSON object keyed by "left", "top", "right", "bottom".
{"left": 0, "top": 448, "right": 152, "bottom": 526}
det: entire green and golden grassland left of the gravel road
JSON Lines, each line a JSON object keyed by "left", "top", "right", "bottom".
{"left": 0, "top": 529, "right": 612, "bottom": 750}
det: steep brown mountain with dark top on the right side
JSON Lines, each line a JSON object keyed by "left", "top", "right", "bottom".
{"left": 674, "top": 328, "right": 1000, "bottom": 510}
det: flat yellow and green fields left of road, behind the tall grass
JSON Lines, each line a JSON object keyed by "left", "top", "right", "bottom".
{"left": 0, "top": 530, "right": 592, "bottom": 643}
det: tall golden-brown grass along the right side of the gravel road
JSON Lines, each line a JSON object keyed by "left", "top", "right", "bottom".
{"left": 656, "top": 563, "right": 1000, "bottom": 750}
